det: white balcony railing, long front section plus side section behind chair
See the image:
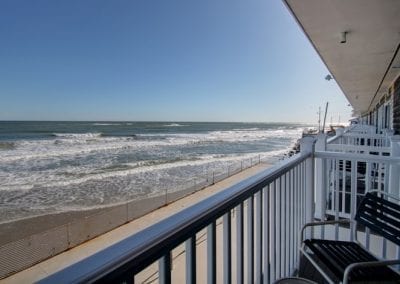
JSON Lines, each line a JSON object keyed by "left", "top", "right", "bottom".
{"left": 30, "top": 126, "right": 400, "bottom": 283}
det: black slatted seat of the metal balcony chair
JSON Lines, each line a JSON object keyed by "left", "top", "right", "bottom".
{"left": 304, "top": 239, "right": 400, "bottom": 282}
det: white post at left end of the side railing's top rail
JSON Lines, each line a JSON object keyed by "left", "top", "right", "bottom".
{"left": 314, "top": 133, "right": 327, "bottom": 220}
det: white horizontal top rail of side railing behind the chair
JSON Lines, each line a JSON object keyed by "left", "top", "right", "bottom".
{"left": 314, "top": 151, "right": 400, "bottom": 164}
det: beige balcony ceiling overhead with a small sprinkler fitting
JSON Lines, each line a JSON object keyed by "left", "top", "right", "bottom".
{"left": 284, "top": 0, "right": 400, "bottom": 114}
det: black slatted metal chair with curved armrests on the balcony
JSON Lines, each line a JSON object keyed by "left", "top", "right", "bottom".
{"left": 301, "top": 193, "right": 400, "bottom": 284}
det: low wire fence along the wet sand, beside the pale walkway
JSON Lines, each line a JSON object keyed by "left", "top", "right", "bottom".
{"left": 0, "top": 155, "right": 267, "bottom": 279}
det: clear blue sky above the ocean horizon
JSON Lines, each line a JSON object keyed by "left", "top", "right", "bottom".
{"left": 0, "top": 0, "right": 351, "bottom": 123}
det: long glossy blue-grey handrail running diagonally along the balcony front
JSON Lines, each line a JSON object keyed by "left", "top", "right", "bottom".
{"left": 39, "top": 152, "right": 312, "bottom": 283}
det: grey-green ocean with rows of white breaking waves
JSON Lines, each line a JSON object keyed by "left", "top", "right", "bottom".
{"left": 0, "top": 121, "right": 307, "bottom": 222}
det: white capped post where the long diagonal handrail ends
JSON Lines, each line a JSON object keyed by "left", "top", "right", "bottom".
{"left": 300, "top": 137, "right": 315, "bottom": 238}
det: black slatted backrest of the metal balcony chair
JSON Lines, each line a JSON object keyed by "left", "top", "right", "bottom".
{"left": 355, "top": 193, "right": 400, "bottom": 246}
